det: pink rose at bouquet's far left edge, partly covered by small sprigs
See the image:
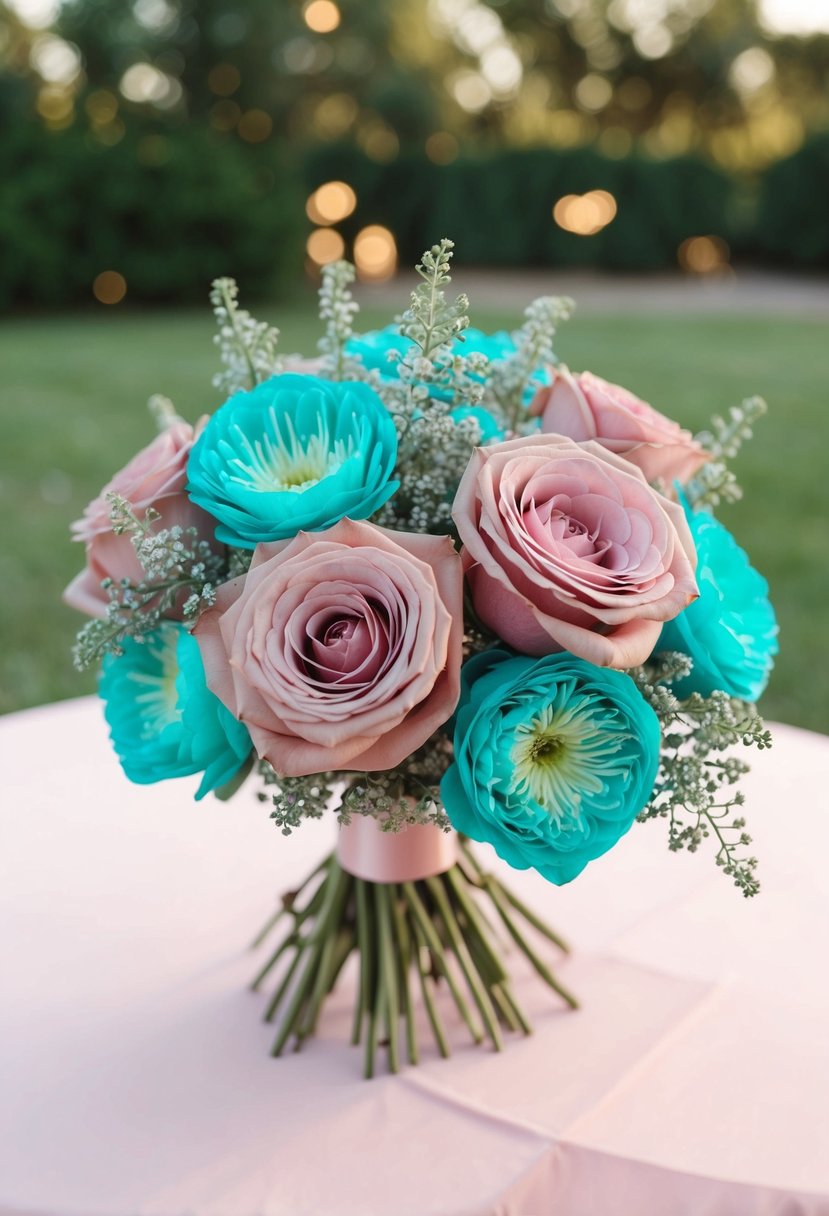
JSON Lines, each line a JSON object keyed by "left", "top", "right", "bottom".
{"left": 63, "top": 420, "right": 215, "bottom": 617}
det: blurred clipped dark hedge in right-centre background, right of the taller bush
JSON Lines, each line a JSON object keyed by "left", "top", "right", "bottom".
{"left": 304, "top": 143, "right": 734, "bottom": 270}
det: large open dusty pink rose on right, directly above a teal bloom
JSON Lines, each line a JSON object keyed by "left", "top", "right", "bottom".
{"left": 452, "top": 435, "right": 698, "bottom": 668}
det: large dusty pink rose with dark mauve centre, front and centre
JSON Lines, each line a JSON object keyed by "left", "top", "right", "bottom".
{"left": 196, "top": 519, "right": 463, "bottom": 777}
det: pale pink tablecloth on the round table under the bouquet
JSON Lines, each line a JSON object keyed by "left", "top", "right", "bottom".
{"left": 0, "top": 700, "right": 829, "bottom": 1216}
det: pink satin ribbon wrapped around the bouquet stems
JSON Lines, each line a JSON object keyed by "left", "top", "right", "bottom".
{"left": 337, "top": 815, "right": 457, "bottom": 883}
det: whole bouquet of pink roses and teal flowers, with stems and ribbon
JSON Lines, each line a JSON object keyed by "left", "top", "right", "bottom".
{"left": 66, "top": 241, "right": 777, "bottom": 1076}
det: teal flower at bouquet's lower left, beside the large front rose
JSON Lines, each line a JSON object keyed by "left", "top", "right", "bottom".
{"left": 100, "top": 621, "right": 252, "bottom": 799}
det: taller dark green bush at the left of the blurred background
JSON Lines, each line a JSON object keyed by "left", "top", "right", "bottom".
{"left": 0, "top": 123, "right": 301, "bottom": 309}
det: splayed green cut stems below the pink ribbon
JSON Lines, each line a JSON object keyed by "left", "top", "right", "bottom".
{"left": 252, "top": 841, "right": 577, "bottom": 1077}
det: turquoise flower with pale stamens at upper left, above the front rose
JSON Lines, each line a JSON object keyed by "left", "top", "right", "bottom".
{"left": 187, "top": 375, "right": 399, "bottom": 548}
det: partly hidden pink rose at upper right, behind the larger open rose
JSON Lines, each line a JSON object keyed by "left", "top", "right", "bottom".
{"left": 530, "top": 367, "right": 709, "bottom": 490}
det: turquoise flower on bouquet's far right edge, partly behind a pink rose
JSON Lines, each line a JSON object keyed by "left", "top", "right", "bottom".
{"left": 656, "top": 495, "right": 778, "bottom": 700}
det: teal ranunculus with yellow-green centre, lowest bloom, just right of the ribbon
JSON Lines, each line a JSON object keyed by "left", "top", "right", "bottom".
{"left": 440, "top": 648, "right": 661, "bottom": 885}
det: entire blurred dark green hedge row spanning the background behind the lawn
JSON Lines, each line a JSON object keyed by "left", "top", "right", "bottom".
{"left": 0, "top": 123, "right": 829, "bottom": 309}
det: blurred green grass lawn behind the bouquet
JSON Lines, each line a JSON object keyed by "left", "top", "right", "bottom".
{"left": 0, "top": 302, "right": 829, "bottom": 731}
